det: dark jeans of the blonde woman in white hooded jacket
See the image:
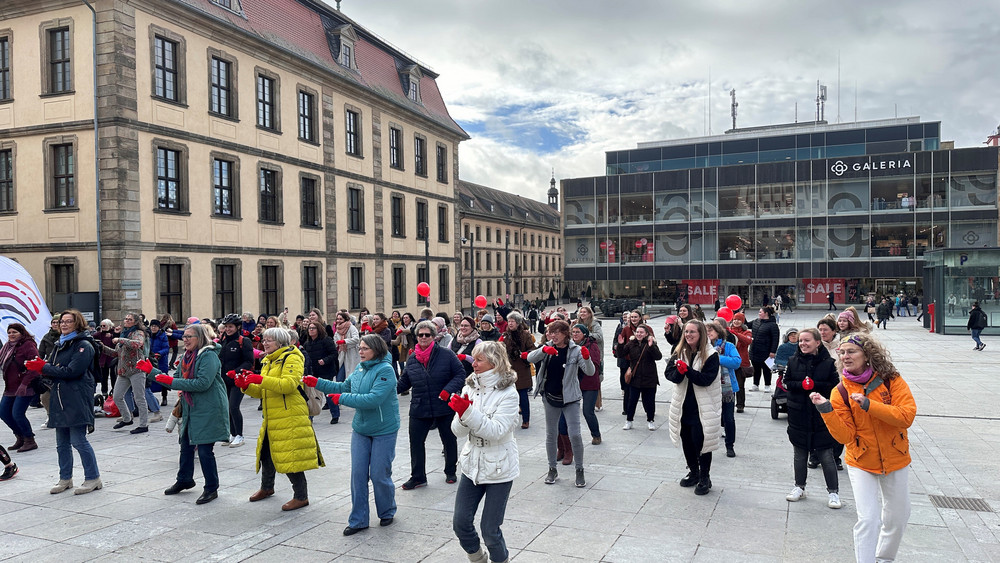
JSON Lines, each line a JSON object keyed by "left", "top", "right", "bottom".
{"left": 451, "top": 475, "right": 514, "bottom": 561}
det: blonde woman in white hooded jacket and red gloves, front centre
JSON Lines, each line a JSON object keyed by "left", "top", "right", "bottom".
{"left": 450, "top": 342, "right": 520, "bottom": 563}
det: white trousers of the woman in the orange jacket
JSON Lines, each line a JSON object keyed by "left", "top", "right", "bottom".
{"left": 847, "top": 466, "right": 910, "bottom": 563}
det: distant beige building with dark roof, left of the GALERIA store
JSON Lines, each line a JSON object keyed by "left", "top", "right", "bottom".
{"left": 458, "top": 178, "right": 563, "bottom": 308}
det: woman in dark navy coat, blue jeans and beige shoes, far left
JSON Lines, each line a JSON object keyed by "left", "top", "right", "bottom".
{"left": 25, "top": 309, "right": 104, "bottom": 495}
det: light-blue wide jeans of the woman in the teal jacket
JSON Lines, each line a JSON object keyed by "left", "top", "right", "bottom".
{"left": 347, "top": 432, "right": 396, "bottom": 528}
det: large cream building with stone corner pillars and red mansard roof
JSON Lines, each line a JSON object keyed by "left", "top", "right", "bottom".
{"left": 0, "top": 0, "right": 468, "bottom": 319}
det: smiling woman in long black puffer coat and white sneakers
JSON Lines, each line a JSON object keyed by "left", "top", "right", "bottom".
{"left": 783, "top": 328, "right": 841, "bottom": 508}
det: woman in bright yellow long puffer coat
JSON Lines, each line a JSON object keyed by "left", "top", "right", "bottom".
{"left": 236, "top": 328, "right": 326, "bottom": 511}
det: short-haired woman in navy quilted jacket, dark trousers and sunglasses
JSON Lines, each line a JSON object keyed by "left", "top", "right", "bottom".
{"left": 396, "top": 321, "right": 465, "bottom": 491}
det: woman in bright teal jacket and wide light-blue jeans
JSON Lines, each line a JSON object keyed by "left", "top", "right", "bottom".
{"left": 302, "top": 334, "right": 399, "bottom": 536}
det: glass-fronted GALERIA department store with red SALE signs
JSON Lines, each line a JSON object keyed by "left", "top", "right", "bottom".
{"left": 562, "top": 117, "right": 998, "bottom": 304}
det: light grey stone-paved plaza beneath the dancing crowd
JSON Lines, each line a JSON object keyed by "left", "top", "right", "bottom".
{"left": 0, "top": 310, "right": 1000, "bottom": 563}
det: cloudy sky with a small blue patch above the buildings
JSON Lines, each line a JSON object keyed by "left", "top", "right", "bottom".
{"left": 327, "top": 0, "right": 1000, "bottom": 204}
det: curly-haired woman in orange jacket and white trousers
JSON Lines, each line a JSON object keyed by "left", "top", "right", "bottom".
{"left": 809, "top": 333, "right": 917, "bottom": 563}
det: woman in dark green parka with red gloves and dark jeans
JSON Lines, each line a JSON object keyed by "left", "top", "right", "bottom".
{"left": 136, "top": 324, "right": 229, "bottom": 504}
